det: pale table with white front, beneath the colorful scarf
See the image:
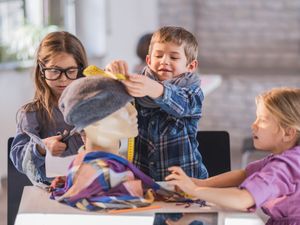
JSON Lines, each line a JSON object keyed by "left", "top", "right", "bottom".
{"left": 15, "top": 186, "right": 264, "bottom": 225}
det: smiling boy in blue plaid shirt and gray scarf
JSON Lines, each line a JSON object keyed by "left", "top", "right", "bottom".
{"left": 106, "top": 26, "right": 208, "bottom": 181}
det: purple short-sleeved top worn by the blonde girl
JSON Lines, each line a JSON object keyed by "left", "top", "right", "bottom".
{"left": 240, "top": 146, "right": 300, "bottom": 225}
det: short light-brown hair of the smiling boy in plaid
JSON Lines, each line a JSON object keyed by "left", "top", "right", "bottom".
{"left": 148, "top": 26, "right": 198, "bottom": 64}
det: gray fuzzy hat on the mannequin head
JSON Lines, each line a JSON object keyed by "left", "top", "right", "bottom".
{"left": 58, "top": 76, "right": 132, "bottom": 131}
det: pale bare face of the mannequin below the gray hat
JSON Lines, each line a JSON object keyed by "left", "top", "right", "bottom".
{"left": 84, "top": 103, "right": 138, "bottom": 147}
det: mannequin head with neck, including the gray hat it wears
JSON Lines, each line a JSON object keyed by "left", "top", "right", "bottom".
{"left": 59, "top": 77, "right": 138, "bottom": 153}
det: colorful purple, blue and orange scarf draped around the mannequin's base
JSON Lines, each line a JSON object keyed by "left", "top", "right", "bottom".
{"left": 51, "top": 151, "right": 182, "bottom": 211}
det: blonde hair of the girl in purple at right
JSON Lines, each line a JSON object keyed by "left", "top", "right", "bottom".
{"left": 256, "top": 88, "right": 300, "bottom": 144}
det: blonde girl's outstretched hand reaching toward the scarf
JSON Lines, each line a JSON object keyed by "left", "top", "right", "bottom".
{"left": 165, "top": 166, "right": 198, "bottom": 196}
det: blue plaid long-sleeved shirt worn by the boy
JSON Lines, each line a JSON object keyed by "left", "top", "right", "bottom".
{"left": 134, "top": 75, "right": 208, "bottom": 181}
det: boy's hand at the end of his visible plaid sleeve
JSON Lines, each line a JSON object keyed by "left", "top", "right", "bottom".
{"left": 122, "top": 74, "right": 164, "bottom": 99}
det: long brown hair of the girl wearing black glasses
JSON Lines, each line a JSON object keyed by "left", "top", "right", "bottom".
{"left": 23, "top": 31, "right": 88, "bottom": 124}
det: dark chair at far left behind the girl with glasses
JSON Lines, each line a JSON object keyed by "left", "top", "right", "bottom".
{"left": 7, "top": 137, "right": 32, "bottom": 225}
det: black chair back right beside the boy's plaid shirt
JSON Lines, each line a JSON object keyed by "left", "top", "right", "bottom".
{"left": 197, "top": 131, "right": 231, "bottom": 177}
